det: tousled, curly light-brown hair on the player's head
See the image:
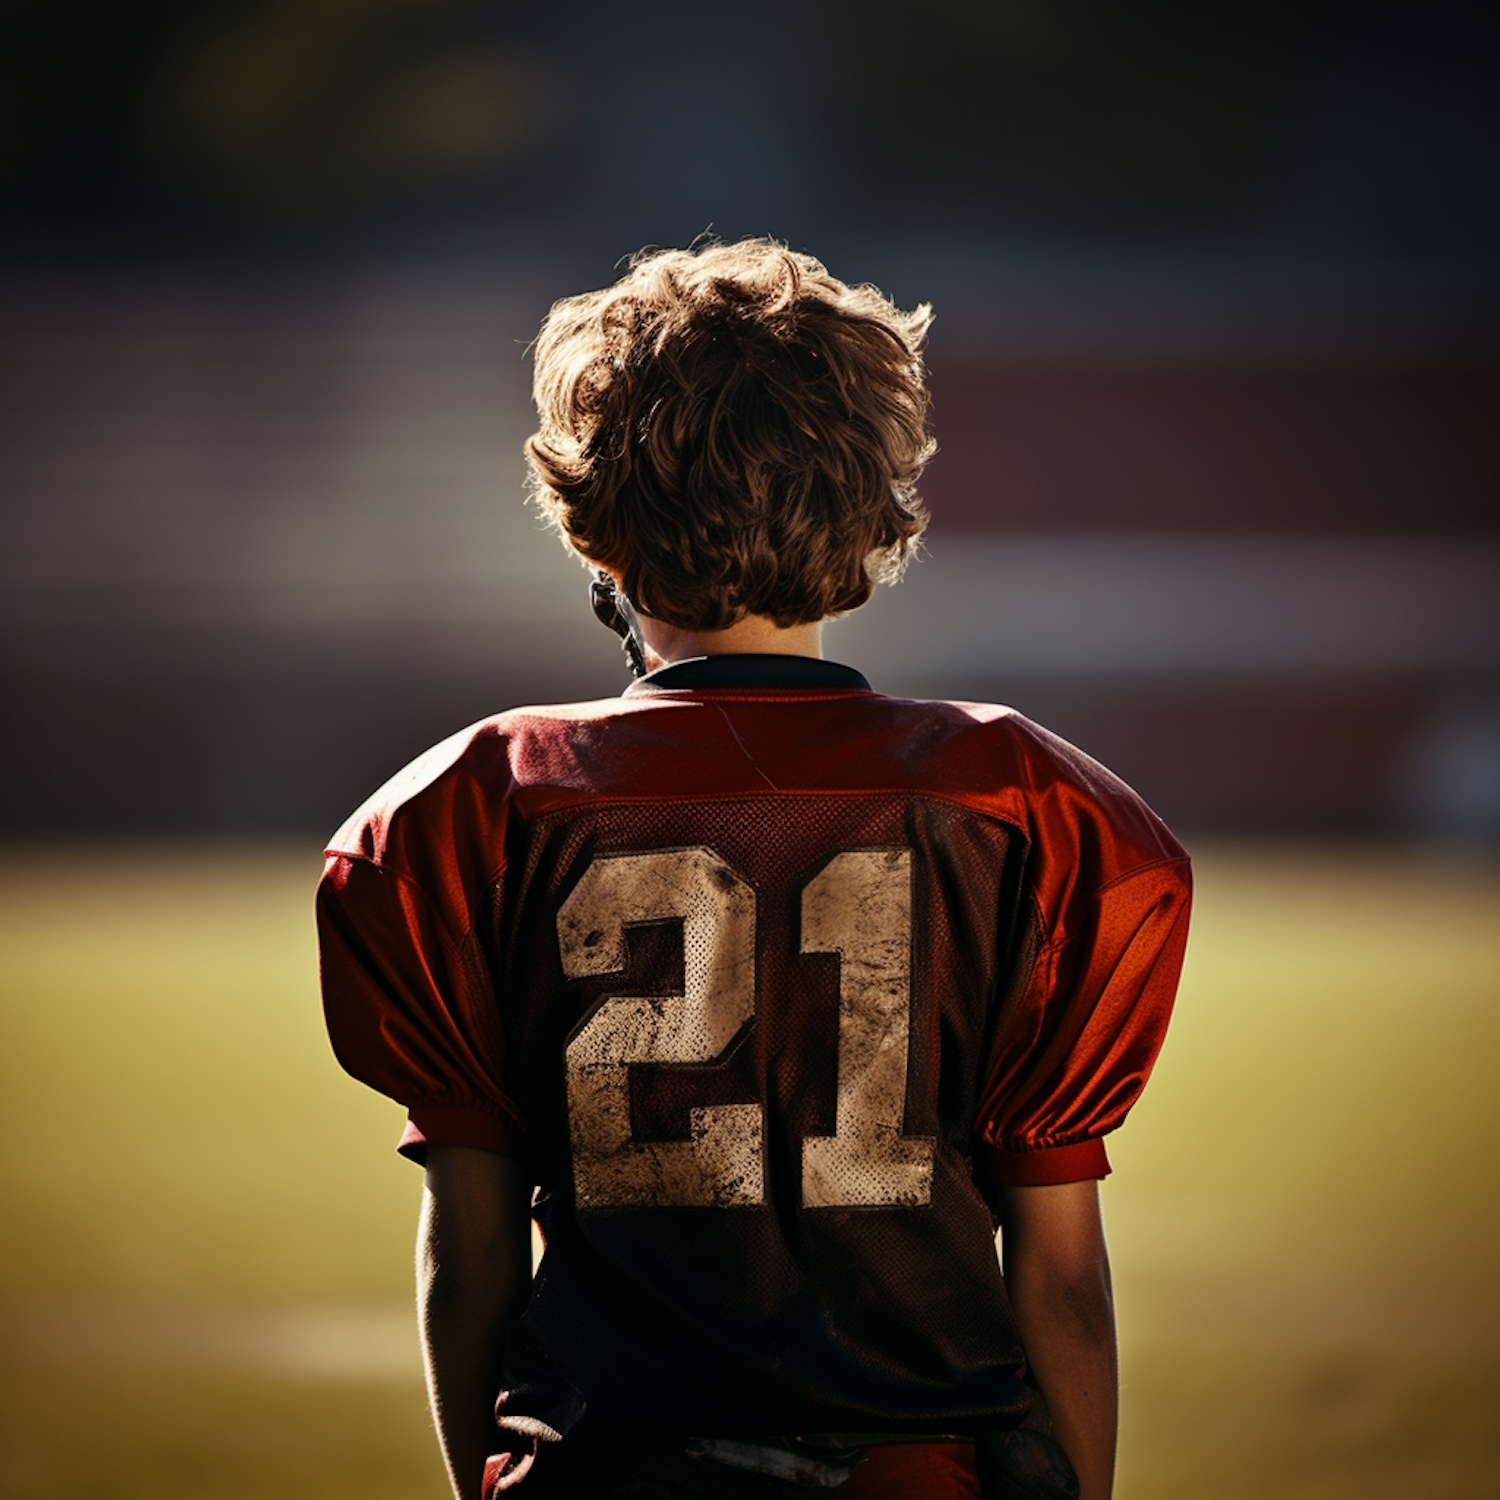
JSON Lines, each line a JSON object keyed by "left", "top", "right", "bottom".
{"left": 527, "top": 240, "right": 933, "bottom": 630}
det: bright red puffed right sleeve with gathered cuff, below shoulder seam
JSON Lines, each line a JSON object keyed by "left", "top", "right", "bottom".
{"left": 978, "top": 855, "right": 1191, "bottom": 1187}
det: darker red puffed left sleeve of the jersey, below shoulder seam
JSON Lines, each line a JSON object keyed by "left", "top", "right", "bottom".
{"left": 318, "top": 852, "right": 524, "bottom": 1161}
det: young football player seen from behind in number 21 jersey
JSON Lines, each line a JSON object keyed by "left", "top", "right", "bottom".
{"left": 320, "top": 240, "right": 1188, "bottom": 1500}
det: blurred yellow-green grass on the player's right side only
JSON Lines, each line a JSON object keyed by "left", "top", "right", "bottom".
{"left": 1106, "top": 849, "right": 1500, "bottom": 1500}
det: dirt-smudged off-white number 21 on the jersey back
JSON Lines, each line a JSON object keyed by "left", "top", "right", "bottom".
{"left": 558, "top": 849, "right": 935, "bottom": 1208}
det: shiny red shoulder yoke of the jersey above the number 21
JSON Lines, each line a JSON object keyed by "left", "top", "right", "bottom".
{"left": 326, "top": 693, "right": 1185, "bottom": 918}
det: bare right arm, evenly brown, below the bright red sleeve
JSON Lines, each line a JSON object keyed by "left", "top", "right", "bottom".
{"left": 1001, "top": 1182, "right": 1119, "bottom": 1500}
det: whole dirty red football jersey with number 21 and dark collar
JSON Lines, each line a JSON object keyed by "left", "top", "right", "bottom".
{"left": 320, "top": 657, "right": 1190, "bottom": 1452}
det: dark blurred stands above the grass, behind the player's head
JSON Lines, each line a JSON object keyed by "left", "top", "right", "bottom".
{"left": 0, "top": 0, "right": 1500, "bottom": 839}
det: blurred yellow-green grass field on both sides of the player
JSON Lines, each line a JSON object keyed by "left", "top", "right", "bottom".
{"left": 0, "top": 846, "right": 1500, "bottom": 1500}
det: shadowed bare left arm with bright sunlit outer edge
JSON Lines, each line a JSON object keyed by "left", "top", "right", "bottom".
{"left": 417, "top": 1146, "right": 531, "bottom": 1500}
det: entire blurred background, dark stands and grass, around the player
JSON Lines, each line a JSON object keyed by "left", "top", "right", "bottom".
{"left": 0, "top": 0, "right": 1500, "bottom": 1500}
